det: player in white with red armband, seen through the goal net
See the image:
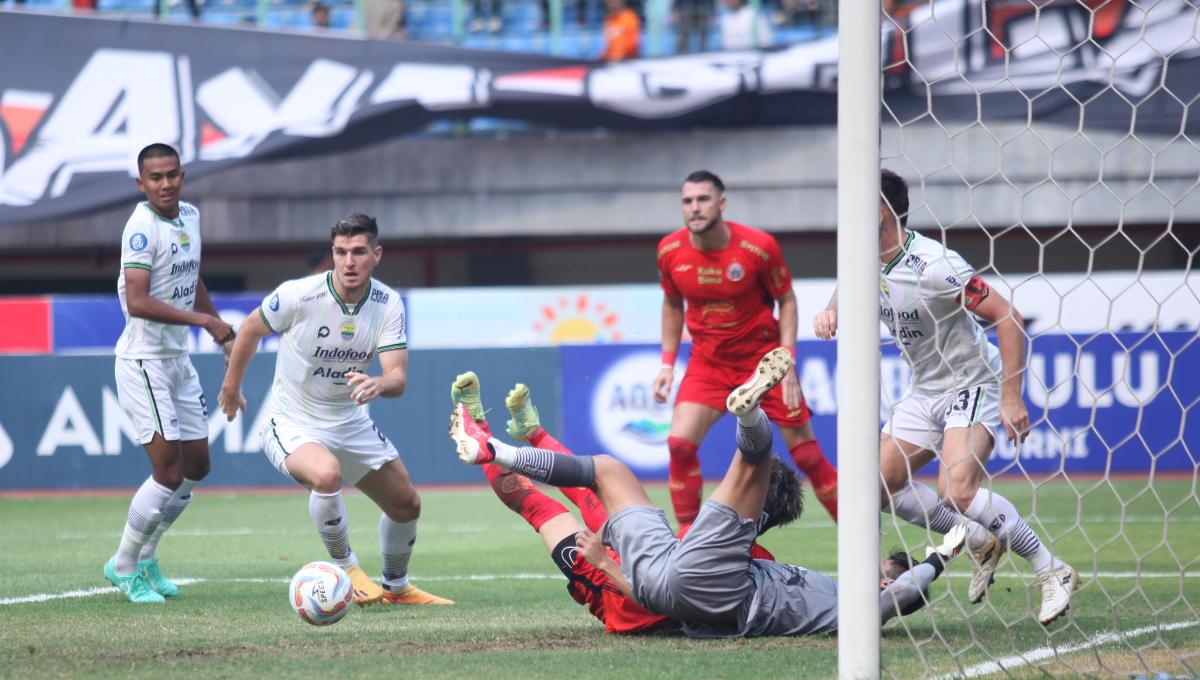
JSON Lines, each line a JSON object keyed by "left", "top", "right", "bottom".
{"left": 812, "top": 170, "right": 1079, "bottom": 625}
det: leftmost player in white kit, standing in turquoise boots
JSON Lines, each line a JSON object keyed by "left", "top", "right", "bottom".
{"left": 103, "top": 144, "right": 234, "bottom": 603}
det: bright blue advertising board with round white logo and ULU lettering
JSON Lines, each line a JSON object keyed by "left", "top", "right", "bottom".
{"left": 560, "top": 331, "right": 1200, "bottom": 480}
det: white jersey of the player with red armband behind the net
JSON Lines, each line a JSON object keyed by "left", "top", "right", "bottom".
{"left": 880, "top": 231, "right": 1001, "bottom": 395}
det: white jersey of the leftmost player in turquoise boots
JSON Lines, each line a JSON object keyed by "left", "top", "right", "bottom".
{"left": 116, "top": 201, "right": 200, "bottom": 359}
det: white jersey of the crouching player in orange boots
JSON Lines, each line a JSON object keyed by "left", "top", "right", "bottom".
{"left": 259, "top": 272, "right": 408, "bottom": 427}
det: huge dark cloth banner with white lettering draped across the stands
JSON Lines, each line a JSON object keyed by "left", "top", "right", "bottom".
{"left": 0, "top": 0, "right": 1200, "bottom": 223}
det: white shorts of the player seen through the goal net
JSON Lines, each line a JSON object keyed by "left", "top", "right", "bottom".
{"left": 883, "top": 384, "right": 1001, "bottom": 453}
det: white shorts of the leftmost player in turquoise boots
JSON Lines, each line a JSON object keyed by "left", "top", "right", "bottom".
{"left": 116, "top": 355, "right": 209, "bottom": 445}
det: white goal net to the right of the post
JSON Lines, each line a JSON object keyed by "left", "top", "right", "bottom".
{"left": 873, "top": 0, "right": 1200, "bottom": 678}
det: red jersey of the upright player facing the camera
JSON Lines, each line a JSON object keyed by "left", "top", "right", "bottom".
{"left": 659, "top": 222, "right": 792, "bottom": 361}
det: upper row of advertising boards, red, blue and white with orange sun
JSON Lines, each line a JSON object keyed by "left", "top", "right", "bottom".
{"left": 0, "top": 271, "right": 1200, "bottom": 354}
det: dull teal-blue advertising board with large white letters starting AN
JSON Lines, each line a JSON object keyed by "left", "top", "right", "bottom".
{"left": 0, "top": 349, "right": 560, "bottom": 489}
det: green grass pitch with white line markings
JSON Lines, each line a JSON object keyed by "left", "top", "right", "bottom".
{"left": 0, "top": 480, "right": 1200, "bottom": 679}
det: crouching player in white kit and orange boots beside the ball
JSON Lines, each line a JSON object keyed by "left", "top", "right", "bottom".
{"left": 217, "top": 212, "right": 454, "bottom": 604}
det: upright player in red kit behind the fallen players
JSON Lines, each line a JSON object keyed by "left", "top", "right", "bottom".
{"left": 653, "top": 170, "right": 838, "bottom": 525}
